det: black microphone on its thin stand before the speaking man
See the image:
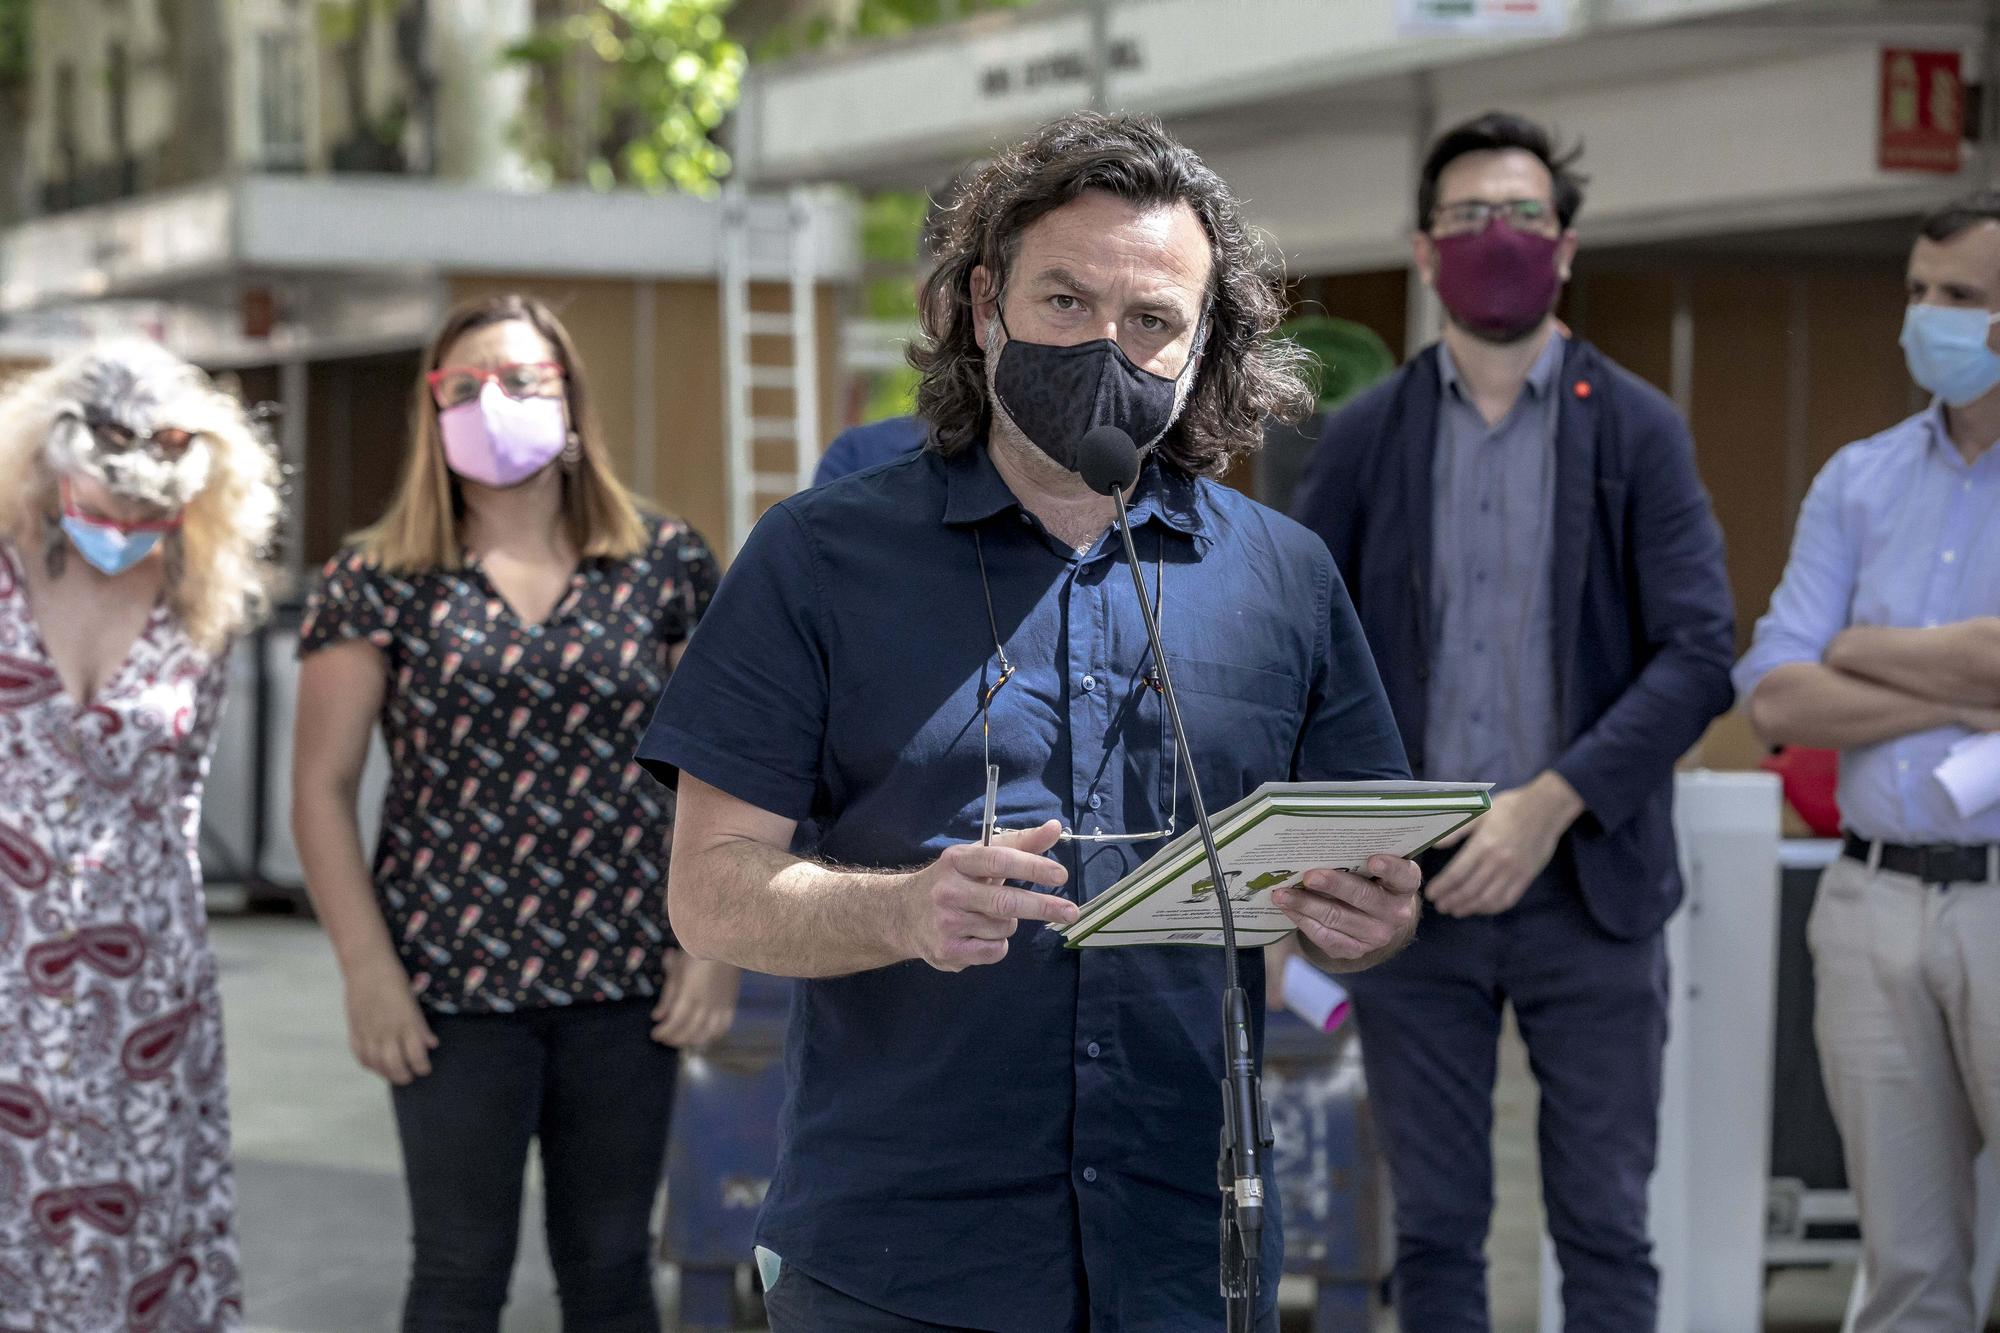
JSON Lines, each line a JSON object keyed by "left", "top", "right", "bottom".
{"left": 1076, "top": 426, "right": 1270, "bottom": 1333}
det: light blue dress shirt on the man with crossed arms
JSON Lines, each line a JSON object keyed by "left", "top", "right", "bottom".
{"left": 1734, "top": 406, "right": 2000, "bottom": 843}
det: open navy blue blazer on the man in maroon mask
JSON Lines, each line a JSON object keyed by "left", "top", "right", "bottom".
{"left": 1292, "top": 340, "right": 1736, "bottom": 939}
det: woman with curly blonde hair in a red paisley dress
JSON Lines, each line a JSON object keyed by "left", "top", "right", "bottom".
{"left": 0, "top": 342, "right": 278, "bottom": 1333}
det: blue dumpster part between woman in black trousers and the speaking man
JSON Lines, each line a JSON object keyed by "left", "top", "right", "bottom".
{"left": 660, "top": 973, "right": 794, "bottom": 1333}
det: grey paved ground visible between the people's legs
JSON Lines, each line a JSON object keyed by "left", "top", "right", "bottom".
{"left": 214, "top": 917, "right": 1880, "bottom": 1333}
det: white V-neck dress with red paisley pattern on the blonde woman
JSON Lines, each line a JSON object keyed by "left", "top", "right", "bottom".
{"left": 0, "top": 542, "right": 242, "bottom": 1333}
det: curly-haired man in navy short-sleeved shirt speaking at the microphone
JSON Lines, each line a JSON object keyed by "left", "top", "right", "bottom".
{"left": 640, "top": 114, "right": 1420, "bottom": 1333}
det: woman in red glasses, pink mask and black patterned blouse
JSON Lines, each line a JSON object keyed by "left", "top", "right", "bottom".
{"left": 292, "top": 296, "right": 738, "bottom": 1333}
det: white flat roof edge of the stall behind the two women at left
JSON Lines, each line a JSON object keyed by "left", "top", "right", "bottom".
{"left": 0, "top": 176, "right": 860, "bottom": 364}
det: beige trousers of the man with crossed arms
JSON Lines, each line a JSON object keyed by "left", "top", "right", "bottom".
{"left": 1806, "top": 857, "right": 2000, "bottom": 1333}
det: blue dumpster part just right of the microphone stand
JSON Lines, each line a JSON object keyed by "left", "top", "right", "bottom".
{"left": 1264, "top": 1009, "right": 1386, "bottom": 1333}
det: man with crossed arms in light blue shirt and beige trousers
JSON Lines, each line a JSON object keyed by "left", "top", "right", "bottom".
{"left": 1736, "top": 194, "right": 2000, "bottom": 1333}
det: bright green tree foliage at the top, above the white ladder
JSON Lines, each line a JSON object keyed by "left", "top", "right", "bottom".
{"left": 508, "top": 0, "right": 746, "bottom": 194}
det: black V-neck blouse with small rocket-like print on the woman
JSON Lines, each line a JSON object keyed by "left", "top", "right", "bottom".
{"left": 300, "top": 520, "right": 716, "bottom": 1013}
